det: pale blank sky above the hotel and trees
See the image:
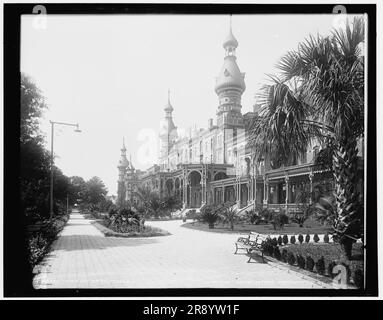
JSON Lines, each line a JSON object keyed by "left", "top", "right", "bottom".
{"left": 21, "top": 15, "right": 352, "bottom": 194}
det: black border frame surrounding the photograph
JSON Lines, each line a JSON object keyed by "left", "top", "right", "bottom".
{"left": 3, "top": 3, "right": 378, "bottom": 303}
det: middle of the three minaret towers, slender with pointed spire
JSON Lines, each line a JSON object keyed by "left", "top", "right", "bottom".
{"left": 160, "top": 90, "right": 177, "bottom": 166}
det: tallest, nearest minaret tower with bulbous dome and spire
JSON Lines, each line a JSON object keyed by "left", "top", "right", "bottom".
{"left": 215, "top": 17, "right": 246, "bottom": 128}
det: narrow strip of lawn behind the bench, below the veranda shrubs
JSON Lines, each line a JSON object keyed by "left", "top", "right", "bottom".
{"left": 182, "top": 221, "right": 331, "bottom": 235}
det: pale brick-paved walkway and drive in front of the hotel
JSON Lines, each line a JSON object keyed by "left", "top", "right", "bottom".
{"left": 34, "top": 212, "right": 328, "bottom": 288}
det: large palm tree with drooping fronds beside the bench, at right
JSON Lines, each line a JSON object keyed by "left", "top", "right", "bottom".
{"left": 250, "top": 18, "right": 364, "bottom": 257}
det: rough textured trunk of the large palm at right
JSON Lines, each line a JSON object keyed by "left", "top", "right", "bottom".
{"left": 333, "top": 137, "right": 361, "bottom": 259}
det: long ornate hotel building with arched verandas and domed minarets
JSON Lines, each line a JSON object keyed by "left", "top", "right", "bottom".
{"left": 117, "top": 24, "right": 363, "bottom": 213}
